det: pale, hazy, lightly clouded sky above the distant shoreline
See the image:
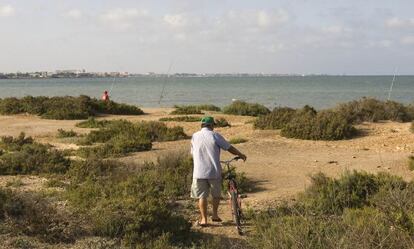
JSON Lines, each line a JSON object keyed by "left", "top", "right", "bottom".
{"left": 0, "top": 0, "right": 414, "bottom": 75}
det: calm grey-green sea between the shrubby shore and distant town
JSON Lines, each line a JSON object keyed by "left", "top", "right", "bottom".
{"left": 0, "top": 76, "right": 414, "bottom": 108}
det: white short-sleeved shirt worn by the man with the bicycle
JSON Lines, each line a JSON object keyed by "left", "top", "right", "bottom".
{"left": 191, "top": 128, "right": 231, "bottom": 179}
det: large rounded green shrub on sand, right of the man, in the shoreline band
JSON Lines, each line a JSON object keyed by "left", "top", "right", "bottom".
{"left": 281, "top": 111, "right": 357, "bottom": 140}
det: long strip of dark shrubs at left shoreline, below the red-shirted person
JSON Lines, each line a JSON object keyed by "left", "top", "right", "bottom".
{"left": 0, "top": 95, "right": 144, "bottom": 120}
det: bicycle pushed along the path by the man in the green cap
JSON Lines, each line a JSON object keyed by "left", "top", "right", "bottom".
{"left": 220, "top": 157, "right": 243, "bottom": 235}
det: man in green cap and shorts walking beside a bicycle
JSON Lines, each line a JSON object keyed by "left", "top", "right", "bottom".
{"left": 191, "top": 117, "right": 246, "bottom": 227}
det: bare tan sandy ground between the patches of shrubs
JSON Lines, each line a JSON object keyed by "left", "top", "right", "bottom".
{"left": 0, "top": 108, "right": 414, "bottom": 240}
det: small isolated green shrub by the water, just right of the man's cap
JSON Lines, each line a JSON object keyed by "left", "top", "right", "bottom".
{"left": 223, "top": 100, "right": 270, "bottom": 116}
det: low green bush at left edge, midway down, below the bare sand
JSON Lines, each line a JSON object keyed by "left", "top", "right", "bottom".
{"left": 0, "top": 133, "right": 70, "bottom": 175}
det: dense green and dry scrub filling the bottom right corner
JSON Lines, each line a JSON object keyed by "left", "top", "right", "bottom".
{"left": 249, "top": 172, "right": 414, "bottom": 249}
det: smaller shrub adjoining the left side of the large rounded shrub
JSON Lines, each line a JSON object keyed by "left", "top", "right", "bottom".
{"left": 253, "top": 107, "right": 296, "bottom": 130}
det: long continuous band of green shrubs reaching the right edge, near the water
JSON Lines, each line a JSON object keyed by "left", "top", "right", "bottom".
{"left": 254, "top": 98, "right": 414, "bottom": 140}
